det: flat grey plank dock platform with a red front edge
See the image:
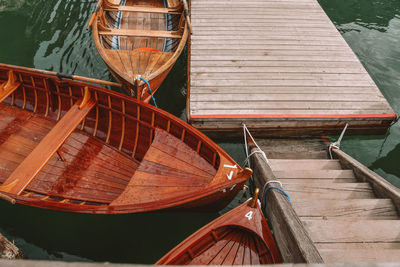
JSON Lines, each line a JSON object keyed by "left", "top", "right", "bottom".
{"left": 187, "top": 0, "right": 396, "bottom": 135}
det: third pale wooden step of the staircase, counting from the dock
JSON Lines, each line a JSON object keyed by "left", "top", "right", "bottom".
{"left": 283, "top": 183, "right": 375, "bottom": 201}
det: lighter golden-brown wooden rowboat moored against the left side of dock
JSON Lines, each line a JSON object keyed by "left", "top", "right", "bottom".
{"left": 93, "top": 0, "right": 188, "bottom": 102}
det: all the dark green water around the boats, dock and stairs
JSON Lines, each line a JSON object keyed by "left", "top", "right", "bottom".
{"left": 0, "top": 0, "right": 400, "bottom": 263}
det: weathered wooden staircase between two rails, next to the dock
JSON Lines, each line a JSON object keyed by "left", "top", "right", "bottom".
{"left": 250, "top": 139, "right": 400, "bottom": 263}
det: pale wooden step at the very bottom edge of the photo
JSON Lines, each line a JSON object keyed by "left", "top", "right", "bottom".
{"left": 319, "top": 249, "right": 400, "bottom": 263}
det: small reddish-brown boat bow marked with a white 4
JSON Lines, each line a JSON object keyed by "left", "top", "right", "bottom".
{"left": 156, "top": 189, "right": 282, "bottom": 265}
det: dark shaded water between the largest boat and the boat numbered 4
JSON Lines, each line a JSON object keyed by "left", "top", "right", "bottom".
{"left": 0, "top": 202, "right": 218, "bottom": 263}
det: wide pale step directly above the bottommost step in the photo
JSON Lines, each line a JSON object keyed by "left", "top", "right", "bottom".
{"left": 303, "top": 219, "right": 400, "bottom": 243}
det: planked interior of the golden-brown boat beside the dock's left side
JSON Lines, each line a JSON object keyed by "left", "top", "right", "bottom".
{"left": 95, "top": 0, "right": 185, "bottom": 82}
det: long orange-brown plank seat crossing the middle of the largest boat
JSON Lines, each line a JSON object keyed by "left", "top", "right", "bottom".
{"left": 0, "top": 87, "right": 96, "bottom": 195}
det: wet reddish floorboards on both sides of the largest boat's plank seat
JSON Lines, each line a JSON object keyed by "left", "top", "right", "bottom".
{"left": 0, "top": 105, "right": 138, "bottom": 203}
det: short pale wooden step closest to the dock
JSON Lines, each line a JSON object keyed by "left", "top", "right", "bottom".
{"left": 269, "top": 159, "right": 342, "bottom": 171}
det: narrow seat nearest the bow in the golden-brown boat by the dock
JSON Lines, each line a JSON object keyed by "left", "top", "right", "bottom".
{"left": 99, "top": 26, "right": 182, "bottom": 39}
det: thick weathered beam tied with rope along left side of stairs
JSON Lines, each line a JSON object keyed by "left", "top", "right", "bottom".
{"left": 251, "top": 147, "right": 323, "bottom": 263}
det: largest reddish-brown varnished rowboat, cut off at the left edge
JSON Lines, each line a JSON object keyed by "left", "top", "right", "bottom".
{"left": 0, "top": 64, "right": 251, "bottom": 213}
